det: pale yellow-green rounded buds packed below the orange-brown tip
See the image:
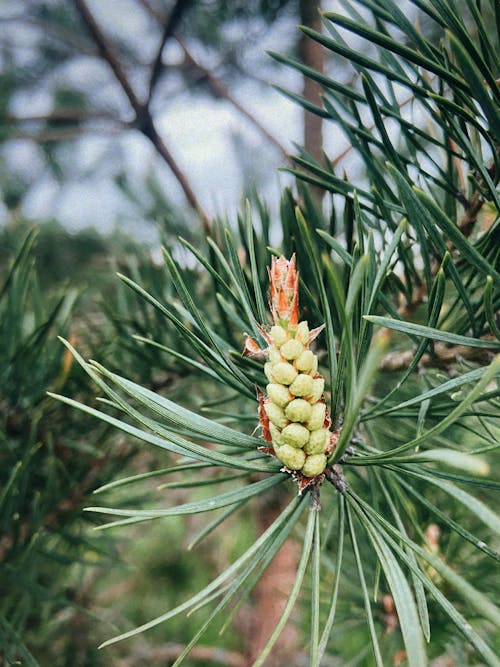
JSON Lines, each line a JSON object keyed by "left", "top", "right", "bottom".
{"left": 263, "top": 320, "right": 330, "bottom": 477}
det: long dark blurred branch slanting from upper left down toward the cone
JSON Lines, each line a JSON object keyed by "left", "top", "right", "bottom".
{"left": 73, "top": 0, "right": 211, "bottom": 233}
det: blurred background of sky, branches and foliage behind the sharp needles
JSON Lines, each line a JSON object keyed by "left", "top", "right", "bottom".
{"left": 0, "top": 0, "right": 336, "bottom": 667}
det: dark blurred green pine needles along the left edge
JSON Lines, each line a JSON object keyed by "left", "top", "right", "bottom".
{"left": 0, "top": 230, "right": 143, "bottom": 665}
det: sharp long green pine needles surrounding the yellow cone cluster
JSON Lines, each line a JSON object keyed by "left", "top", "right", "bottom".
{"left": 4, "top": 0, "right": 500, "bottom": 667}
